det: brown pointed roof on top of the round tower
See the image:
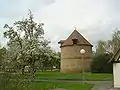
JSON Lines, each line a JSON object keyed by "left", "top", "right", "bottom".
{"left": 58, "top": 30, "right": 92, "bottom": 47}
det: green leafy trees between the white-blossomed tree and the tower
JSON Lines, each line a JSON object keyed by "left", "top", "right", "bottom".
{"left": 40, "top": 48, "right": 60, "bottom": 71}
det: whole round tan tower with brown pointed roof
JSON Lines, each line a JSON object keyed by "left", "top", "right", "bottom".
{"left": 58, "top": 30, "right": 92, "bottom": 73}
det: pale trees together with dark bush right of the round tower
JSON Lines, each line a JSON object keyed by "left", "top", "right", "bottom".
{"left": 91, "top": 29, "right": 120, "bottom": 73}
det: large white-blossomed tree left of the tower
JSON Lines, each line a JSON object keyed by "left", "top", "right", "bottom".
{"left": 4, "top": 11, "right": 50, "bottom": 76}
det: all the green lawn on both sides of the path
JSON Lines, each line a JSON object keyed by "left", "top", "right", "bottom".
{"left": 0, "top": 71, "right": 112, "bottom": 90}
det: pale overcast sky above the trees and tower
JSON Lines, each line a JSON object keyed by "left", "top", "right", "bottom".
{"left": 0, "top": 0, "right": 120, "bottom": 51}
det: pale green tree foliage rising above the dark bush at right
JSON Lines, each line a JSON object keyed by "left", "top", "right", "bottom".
{"left": 96, "top": 29, "right": 120, "bottom": 54}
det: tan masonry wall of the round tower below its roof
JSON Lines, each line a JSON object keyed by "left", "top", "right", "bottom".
{"left": 61, "top": 45, "right": 92, "bottom": 73}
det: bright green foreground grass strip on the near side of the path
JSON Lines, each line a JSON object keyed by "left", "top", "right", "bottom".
{"left": 28, "top": 82, "right": 93, "bottom": 90}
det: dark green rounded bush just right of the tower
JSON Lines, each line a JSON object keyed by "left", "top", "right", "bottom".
{"left": 91, "top": 53, "right": 112, "bottom": 73}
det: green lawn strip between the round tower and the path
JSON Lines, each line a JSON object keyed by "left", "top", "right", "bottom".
{"left": 36, "top": 71, "right": 113, "bottom": 81}
